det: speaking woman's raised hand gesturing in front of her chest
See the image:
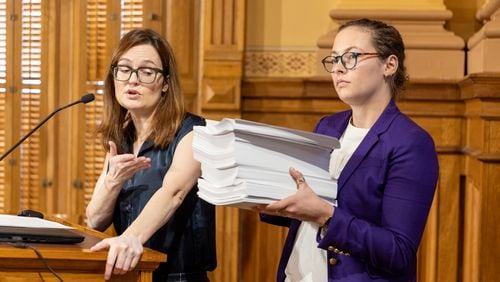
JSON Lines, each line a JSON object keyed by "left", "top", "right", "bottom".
{"left": 106, "top": 141, "right": 151, "bottom": 187}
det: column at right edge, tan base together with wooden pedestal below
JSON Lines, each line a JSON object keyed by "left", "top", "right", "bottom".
{"left": 460, "top": 0, "right": 500, "bottom": 281}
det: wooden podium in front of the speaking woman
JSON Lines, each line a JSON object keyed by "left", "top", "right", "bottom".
{"left": 0, "top": 217, "right": 167, "bottom": 282}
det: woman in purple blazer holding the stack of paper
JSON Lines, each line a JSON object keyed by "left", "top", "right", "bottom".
{"left": 261, "top": 19, "right": 439, "bottom": 281}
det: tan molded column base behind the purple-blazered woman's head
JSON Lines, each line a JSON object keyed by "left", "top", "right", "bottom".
{"left": 317, "top": 9, "right": 465, "bottom": 80}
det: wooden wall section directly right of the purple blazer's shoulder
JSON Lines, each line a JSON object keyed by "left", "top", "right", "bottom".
{"left": 386, "top": 79, "right": 465, "bottom": 282}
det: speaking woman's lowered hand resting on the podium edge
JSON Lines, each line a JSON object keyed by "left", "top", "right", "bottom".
{"left": 90, "top": 234, "right": 144, "bottom": 280}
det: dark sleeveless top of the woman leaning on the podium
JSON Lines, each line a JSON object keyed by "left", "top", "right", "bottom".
{"left": 113, "top": 113, "right": 217, "bottom": 274}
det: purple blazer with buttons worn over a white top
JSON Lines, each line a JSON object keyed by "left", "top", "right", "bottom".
{"left": 261, "top": 101, "right": 439, "bottom": 282}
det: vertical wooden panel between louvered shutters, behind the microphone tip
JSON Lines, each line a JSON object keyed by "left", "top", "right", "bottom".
{"left": 53, "top": 1, "right": 86, "bottom": 222}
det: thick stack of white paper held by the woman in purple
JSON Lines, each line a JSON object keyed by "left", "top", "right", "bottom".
{"left": 193, "top": 118, "right": 340, "bottom": 207}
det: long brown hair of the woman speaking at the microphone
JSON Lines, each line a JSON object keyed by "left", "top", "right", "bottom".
{"left": 97, "top": 29, "right": 185, "bottom": 153}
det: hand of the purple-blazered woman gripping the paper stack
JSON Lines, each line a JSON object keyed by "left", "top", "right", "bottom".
{"left": 259, "top": 168, "right": 334, "bottom": 225}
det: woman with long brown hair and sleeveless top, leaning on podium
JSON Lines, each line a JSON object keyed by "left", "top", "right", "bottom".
{"left": 87, "top": 29, "right": 216, "bottom": 281}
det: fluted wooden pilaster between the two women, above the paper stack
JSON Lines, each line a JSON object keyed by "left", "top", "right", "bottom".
{"left": 199, "top": 0, "right": 245, "bottom": 118}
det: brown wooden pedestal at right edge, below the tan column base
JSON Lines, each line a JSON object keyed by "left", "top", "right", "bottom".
{"left": 460, "top": 73, "right": 500, "bottom": 281}
